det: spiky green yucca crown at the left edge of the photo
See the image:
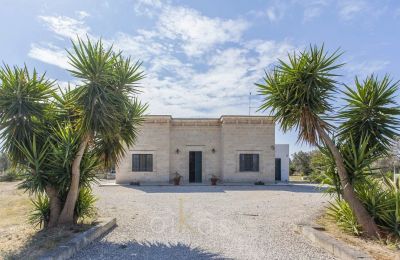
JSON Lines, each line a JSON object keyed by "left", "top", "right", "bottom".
{"left": 0, "top": 65, "right": 54, "bottom": 161}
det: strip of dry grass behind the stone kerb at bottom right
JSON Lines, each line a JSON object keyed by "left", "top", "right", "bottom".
{"left": 317, "top": 215, "right": 400, "bottom": 260}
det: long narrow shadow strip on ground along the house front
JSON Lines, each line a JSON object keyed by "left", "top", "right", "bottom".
{"left": 121, "top": 184, "right": 324, "bottom": 193}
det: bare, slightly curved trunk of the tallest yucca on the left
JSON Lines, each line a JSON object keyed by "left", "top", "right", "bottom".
{"left": 58, "top": 135, "right": 89, "bottom": 225}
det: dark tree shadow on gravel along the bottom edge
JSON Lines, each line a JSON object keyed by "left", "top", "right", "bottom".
{"left": 73, "top": 241, "right": 227, "bottom": 260}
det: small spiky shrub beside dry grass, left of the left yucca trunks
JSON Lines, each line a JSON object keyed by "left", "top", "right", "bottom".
{"left": 29, "top": 193, "right": 50, "bottom": 228}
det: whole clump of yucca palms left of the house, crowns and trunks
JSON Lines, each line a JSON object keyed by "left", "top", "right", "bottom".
{"left": 0, "top": 39, "right": 147, "bottom": 227}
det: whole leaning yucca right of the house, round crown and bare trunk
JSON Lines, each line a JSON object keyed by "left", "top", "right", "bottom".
{"left": 256, "top": 46, "right": 379, "bottom": 237}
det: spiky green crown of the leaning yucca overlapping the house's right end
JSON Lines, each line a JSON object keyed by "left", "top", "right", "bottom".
{"left": 256, "top": 46, "right": 343, "bottom": 144}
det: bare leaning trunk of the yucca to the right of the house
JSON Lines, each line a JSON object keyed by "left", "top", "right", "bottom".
{"left": 318, "top": 128, "right": 379, "bottom": 237}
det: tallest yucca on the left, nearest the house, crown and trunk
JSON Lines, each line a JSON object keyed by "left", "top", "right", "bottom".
{"left": 59, "top": 38, "right": 146, "bottom": 224}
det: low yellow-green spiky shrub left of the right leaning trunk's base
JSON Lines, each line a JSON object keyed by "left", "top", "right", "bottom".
{"left": 327, "top": 199, "right": 362, "bottom": 236}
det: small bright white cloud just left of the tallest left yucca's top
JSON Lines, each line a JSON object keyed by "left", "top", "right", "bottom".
{"left": 28, "top": 44, "right": 72, "bottom": 69}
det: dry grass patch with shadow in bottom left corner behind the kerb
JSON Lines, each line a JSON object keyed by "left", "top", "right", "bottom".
{"left": 0, "top": 182, "right": 89, "bottom": 259}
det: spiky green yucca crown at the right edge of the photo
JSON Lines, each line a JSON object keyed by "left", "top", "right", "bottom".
{"left": 340, "top": 75, "right": 400, "bottom": 154}
